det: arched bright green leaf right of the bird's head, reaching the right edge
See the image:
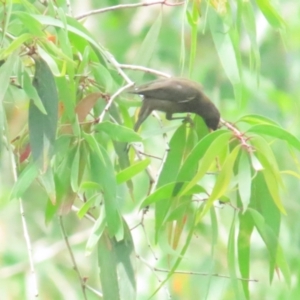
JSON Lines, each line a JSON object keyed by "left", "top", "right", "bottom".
{"left": 247, "top": 124, "right": 300, "bottom": 151}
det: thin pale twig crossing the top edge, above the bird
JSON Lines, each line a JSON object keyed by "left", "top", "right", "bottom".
{"left": 76, "top": 0, "right": 184, "bottom": 20}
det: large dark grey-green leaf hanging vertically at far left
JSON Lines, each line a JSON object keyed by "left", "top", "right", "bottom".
{"left": 28, "top": 56, "right": 58, "bottom": 165}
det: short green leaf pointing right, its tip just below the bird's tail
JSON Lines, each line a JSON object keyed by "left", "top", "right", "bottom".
{"left": 96, "top": 121, "right": 142, "bottom": 143}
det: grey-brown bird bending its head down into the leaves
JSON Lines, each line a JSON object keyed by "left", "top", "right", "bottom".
{"left": 128, "top": 77, "right": 220, "bottom": 131}
